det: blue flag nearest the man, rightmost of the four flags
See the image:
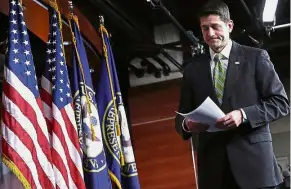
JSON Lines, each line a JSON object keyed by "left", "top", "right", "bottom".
{"left": 97, "top": 25, "right": 140, "bottom": 189}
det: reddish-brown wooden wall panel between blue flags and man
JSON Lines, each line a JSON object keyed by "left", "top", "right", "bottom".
{"left": 129, "top": 80, "right": 195, "bottom": 189}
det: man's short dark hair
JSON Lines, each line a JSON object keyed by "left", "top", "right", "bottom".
{"left": 198, "top": 0, "right": 230, "bottom": 22}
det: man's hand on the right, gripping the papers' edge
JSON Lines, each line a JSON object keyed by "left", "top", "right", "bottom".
{"left": 216, "top": 110, "right": 243, "bottom": 129}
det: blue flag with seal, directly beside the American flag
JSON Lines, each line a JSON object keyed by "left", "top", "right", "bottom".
{"left": 70, "top": 16, "right": 112, "bottom": 189}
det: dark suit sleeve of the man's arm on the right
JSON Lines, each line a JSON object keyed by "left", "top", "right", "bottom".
{"left": 243, "top": 50, "right": 290, "bottom": 128}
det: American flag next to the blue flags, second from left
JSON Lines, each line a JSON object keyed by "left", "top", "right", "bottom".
{"left": 41, "top": 4, "right": 86, "bottom": 189}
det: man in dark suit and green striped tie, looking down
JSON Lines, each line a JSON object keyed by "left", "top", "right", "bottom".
{"left": 176, "top": 1, "right": 289, "bottom": 189}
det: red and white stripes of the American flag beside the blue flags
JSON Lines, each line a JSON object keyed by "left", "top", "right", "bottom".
{"left": 41, "top": 76, "right": 86, "bottom": 189}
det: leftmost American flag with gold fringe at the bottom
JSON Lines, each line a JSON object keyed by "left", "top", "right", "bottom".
{"left": 1, "top": 0, "right": 55, "bottom": 189}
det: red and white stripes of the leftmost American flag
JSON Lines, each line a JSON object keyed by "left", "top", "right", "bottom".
{"left": 1, "top": 66, "right": 55, "bottom": 189}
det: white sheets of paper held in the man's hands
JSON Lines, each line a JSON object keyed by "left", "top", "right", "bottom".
{"left": 176, "top": 97, "right": 226, "bottom": 132}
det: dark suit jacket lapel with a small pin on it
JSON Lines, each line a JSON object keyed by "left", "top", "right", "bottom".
{"left": 222, "top": 41, "right": 244, "bottom": 106}
